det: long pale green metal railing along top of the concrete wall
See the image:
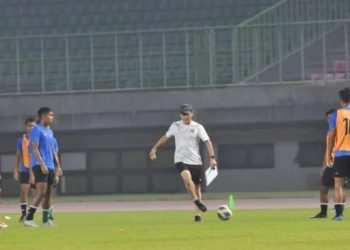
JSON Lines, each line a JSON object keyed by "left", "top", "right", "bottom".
{"left": 0, "top": 18, "right": 350, "bottom": 95}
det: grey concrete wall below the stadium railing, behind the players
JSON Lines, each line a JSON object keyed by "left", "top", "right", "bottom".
{"left": 0, "top": 84, "right": 346, "bottom": 195}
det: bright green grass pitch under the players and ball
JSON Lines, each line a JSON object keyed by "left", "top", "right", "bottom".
{"left": 0, "top": 209, "right": 350, "bottom": 250}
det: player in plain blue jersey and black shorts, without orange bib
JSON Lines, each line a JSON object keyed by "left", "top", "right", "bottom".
{"left": 24, "top": 107, "right": 62, "bottom": 227}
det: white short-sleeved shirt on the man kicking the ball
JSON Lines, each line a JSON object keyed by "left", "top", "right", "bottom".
{"left": 166, "top": 121, "right": 209, "bottom": 165}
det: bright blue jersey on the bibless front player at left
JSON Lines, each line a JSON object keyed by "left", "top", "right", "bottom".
{"left": 30, "top": 124, "right": 55, "bottom": 169}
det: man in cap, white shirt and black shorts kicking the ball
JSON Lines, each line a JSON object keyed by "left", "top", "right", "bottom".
{"left": 150, "top": 104, "right": 217, "bottom": 222}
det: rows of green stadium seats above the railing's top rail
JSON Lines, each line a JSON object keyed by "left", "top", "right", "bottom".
{"left": 0, "top": 0, "right": 278, "bottom": 36}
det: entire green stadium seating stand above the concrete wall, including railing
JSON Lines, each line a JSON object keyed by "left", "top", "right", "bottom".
{"left": 0, "top": 0, "right": 349, "bottom": 94}
